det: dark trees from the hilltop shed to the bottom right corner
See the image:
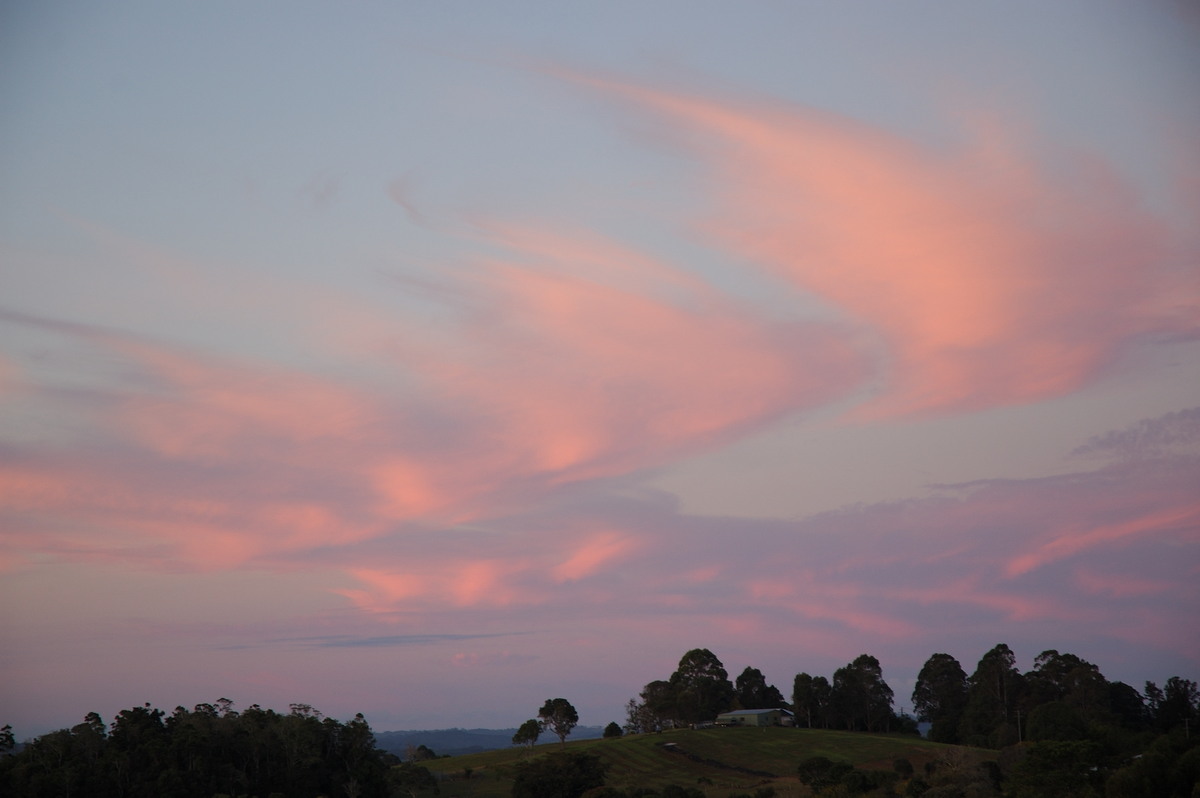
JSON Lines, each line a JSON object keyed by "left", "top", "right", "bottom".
{"left": 625, "top": 643, "right": 1200, "bottom": 798}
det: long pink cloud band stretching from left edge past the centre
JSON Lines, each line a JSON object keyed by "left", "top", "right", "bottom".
{"left": 2, "top": 208, "right": 864, "bottom": 573}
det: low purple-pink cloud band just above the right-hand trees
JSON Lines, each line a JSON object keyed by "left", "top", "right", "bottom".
{"left": 319, "top": 412, "right": 1200, "bottom": 655}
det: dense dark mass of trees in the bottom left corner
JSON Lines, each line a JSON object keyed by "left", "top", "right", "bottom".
{"left": 0, "top": 700, "right": 388, "bottom": 798}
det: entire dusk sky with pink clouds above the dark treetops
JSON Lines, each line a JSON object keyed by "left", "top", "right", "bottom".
{"left": 0, "top": 0, "right": 1200, "bottom": 739}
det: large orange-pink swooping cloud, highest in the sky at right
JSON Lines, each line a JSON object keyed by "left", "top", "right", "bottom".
{"left": 559, "top": 72, "right": 1200, "bottom": 415}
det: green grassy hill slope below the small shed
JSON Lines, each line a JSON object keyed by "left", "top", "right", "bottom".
{"left": 412, "top": 727, "right": 995, "bottom": 798}
